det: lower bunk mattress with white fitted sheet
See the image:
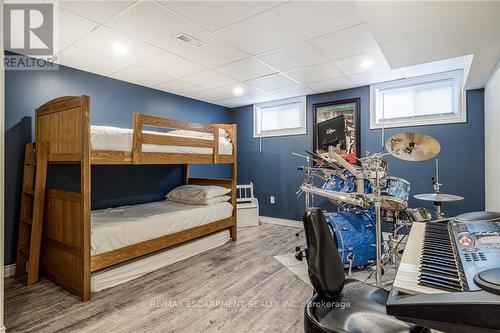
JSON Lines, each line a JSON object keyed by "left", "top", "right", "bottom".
{"left": 91, "top": 200, "right": 233, "bottom": 255}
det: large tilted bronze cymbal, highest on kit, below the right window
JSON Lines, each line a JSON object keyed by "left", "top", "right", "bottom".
{"left": 385, "top": 133, "right": 441, "bottom": 161}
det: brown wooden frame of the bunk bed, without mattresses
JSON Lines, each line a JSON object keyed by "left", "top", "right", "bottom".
{"left": 36, "top": 96, "right": 237, "bottom": 301}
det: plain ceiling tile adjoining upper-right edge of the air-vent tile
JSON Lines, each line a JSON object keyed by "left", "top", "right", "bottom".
{"left": 217, "top": 11, "right": 302, "bottom": 55}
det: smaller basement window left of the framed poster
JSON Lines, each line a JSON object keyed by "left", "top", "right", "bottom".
{"left": 253, "top": 96, "right": 306, "bottom": 138}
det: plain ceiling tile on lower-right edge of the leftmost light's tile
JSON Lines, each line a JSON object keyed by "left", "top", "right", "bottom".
{"left": 138, "top": 52, "right": 204, "bottom": 78}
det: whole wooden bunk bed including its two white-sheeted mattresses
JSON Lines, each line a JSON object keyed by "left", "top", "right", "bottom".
{"left": 36, "top": 96, "right": 237, "bottom": 301}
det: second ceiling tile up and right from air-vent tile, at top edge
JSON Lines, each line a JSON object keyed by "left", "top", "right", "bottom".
{"left": 277, "top": 1, "right": 363, "bottom": 38}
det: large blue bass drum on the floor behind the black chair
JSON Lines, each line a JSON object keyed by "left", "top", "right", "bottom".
{"left": 326, "top": 209, "right": 377, "bottom": 267}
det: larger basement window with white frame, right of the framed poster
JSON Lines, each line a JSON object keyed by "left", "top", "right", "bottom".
{"left": 370, "top": 70, "right": 466, "bottom": 129}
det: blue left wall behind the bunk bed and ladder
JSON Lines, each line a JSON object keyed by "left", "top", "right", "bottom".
{"left": 5, "top": 57, "right": 231, "bottom": 264}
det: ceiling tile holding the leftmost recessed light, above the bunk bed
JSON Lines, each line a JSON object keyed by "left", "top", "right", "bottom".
{"left": 75, "top": 26, "right": 163, "bottom": 64}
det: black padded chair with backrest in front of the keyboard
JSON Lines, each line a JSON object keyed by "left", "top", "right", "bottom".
{"left": 303, "top": 208, "right": 429, "bottom": 333}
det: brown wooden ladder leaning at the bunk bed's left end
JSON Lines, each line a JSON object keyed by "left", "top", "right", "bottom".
{"left": 16, "top": 143, "right": 48, "bottom": 286}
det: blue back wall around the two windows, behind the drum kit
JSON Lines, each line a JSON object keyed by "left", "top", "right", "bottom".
{"left": 232, "top": 87, "right": 484, "bottom": 220}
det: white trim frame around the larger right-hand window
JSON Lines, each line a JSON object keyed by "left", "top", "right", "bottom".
{"left": 370, "top": 69, "right": 467, "bottom": 129}
